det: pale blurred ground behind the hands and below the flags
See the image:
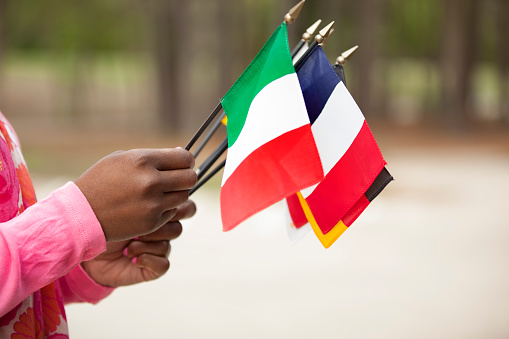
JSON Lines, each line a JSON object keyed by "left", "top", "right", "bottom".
{"left": 23, "top": 126, "right": 509, "bottom": 339}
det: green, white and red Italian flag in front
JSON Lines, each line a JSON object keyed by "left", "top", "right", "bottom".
{"left": 220, "top": 23, "right": 323, "bottom": 231}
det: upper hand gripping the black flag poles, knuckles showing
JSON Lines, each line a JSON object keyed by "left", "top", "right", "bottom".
{"left": 76, "top": 148, "right": 197, "bottom": 241}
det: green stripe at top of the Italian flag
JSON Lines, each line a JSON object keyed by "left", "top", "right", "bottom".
{"left": 221, "top": 23, "right": 295, "bottom": 147}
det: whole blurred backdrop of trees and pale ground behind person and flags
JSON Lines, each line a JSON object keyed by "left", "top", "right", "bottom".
{"left": 0, "top": 0, "right": 509, "bottom": 338}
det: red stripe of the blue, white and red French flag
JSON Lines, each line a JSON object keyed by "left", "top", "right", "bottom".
{"left": 306, "top": 121, "right": 386, "bottom": 234}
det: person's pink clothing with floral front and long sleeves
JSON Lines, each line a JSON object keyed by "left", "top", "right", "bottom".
{"left": 0, "top": 113, "right": 113, "bottom": 338}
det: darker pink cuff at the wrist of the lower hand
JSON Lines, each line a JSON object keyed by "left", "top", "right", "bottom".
{"left": 59, "top": 265, "right": 115, "bottom": 304}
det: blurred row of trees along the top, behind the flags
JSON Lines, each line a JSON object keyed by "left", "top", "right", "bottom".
{"left": 0, "top": 0, "right": 509, "bottom": 131}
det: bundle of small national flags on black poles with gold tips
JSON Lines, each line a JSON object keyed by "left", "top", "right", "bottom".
{"left": 186, "top": 1, "right": 393, "bottom": 248}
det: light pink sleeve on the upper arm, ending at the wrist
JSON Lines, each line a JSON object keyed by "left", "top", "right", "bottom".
{"left": 0, "top": 182, "right": 106, "bottom": 315}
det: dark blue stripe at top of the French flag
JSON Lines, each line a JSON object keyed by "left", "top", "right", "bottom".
{"left": 296, "top": 46, "right": 341, "bottom": 124}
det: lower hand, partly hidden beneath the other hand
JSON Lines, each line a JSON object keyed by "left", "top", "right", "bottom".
{"left": 81, "top": 200, "right": 196, "bottom": 287}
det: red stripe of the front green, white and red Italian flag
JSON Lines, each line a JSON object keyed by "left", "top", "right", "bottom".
{"left": 221, "top": 125, "right": 323, "bottom": 231}
